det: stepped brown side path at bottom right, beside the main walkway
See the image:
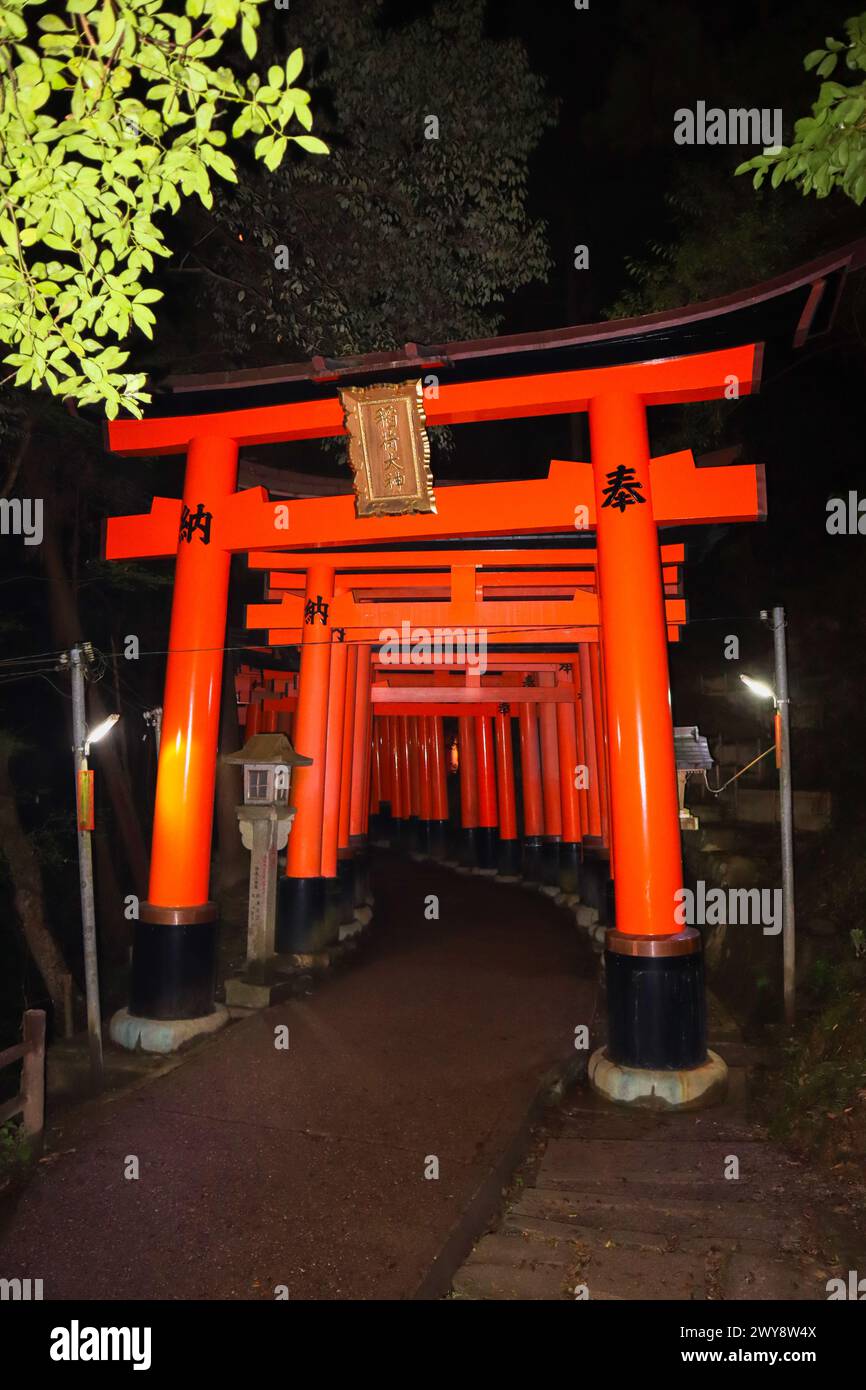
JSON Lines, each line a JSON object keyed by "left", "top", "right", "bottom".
{"left": 453, "top": 1040, "right": 866, "bottom": 1301}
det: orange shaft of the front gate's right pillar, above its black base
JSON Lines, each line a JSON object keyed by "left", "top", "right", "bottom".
{"left": 589, "top": 392, "right": 683, "bottom": 935}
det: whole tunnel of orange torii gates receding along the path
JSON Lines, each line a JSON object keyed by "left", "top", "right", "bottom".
{"left": 106, "top": 246, "right": 862, "bottom": 1098}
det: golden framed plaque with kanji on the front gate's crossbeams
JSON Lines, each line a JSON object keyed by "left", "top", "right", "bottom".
{"left": 339, "top": 379, "right": 436, "bottom": 517}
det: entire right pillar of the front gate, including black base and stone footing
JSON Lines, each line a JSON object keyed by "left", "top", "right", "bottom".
{"left": 589, "top": 391, "right": 726, "bottom": 1105}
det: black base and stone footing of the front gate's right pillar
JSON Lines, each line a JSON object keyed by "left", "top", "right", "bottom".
{"left": 589, "top": 927, "right": 727, "bottom": 1109}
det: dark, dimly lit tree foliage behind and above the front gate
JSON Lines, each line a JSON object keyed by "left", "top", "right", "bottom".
{"left": 160, "top": 0, "right": 556, "bottom": 370}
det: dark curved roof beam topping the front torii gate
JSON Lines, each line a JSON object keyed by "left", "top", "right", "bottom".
{"left": 147, "top": 238, "right": 866, "bottom": 416}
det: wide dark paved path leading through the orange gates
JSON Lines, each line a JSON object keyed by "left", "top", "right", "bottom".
{"left": 0, "top": 855, "right": 596, "bottom": 1300}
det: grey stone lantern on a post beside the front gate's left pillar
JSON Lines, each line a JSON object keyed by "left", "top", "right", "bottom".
{"left": 222, "top": 734, "right": 313, "bottom": 1008}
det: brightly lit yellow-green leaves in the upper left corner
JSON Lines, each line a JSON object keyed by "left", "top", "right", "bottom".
{"left": 0, "top": 0, "right": 328, "bottom": 418}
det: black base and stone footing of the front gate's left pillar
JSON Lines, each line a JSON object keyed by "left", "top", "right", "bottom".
{"left": 110, "top": 902, "right": 228, "bottom": 1052}
